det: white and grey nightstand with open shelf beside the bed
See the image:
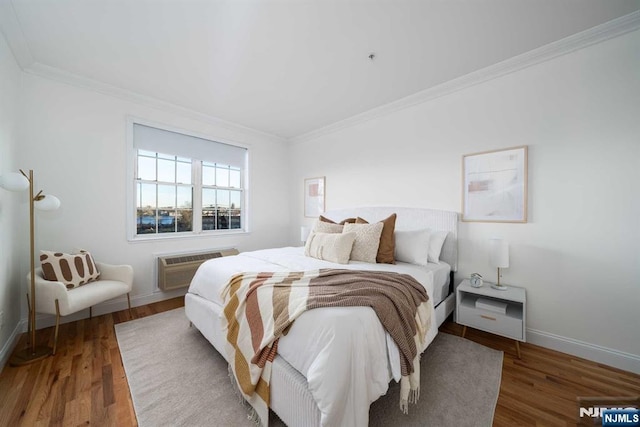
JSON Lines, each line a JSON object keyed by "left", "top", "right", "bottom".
{"left": 456, "top": 279, "right": 527, "bottom": 359}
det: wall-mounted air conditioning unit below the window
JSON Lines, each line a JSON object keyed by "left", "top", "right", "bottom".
{"left": 158, "top": 248, "right": 238, "bottom": 291}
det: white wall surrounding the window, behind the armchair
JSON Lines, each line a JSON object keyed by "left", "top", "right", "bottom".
{"left": 17, "top": 74, "right": 289, "bottom": 325}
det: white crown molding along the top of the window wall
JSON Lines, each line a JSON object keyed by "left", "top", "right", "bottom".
{"left": 24, "top": 62, "right": 287, "bottom": 143}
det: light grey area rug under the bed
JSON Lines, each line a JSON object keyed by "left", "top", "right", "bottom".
{"left": 115, "top": 308, "right": 502, "bottom": 427}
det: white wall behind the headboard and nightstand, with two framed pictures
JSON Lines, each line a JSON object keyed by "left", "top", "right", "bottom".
{"left": 291, "top": 31, "right": 640, "bottom": 371}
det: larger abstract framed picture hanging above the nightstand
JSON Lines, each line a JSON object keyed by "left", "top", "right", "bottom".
{"left": 462, "top": 145, "right": 528, "bottom": 222}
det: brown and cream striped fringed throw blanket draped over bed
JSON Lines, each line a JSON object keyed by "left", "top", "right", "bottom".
{"left": 222, "top": 269, "right": 431, "bottom": 426}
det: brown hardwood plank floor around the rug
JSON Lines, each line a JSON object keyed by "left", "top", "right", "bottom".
{"left": 0, "top": 298, "right": 640, "bottom": 426}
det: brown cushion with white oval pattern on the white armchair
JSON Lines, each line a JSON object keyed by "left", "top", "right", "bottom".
{"left": 40, "top": 251, "right": 100, "bottom": 289}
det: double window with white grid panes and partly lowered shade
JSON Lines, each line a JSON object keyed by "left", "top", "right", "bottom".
{"left": 133, "top": 123, "right": 247, "bottom": 237}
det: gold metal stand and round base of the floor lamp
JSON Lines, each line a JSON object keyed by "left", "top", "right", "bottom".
{"left": 9, "top": 170, "right": 59, "bottom": 366}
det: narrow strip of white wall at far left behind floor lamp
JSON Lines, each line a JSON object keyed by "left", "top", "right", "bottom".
{"left": 0, "top": 35, "right": 23, "bottom": 369}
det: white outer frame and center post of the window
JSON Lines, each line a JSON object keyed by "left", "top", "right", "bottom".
{"left": 126, "top": 117, "right": 251, "bottom": 242}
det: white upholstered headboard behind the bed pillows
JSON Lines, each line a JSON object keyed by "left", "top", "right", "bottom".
{"left": 322, "top": 207, "right": 458, "bottom": 271}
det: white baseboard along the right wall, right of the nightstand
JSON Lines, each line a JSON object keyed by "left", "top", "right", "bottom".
{"left": 527, "top": 329, "right": 640, "bottom": 374}
